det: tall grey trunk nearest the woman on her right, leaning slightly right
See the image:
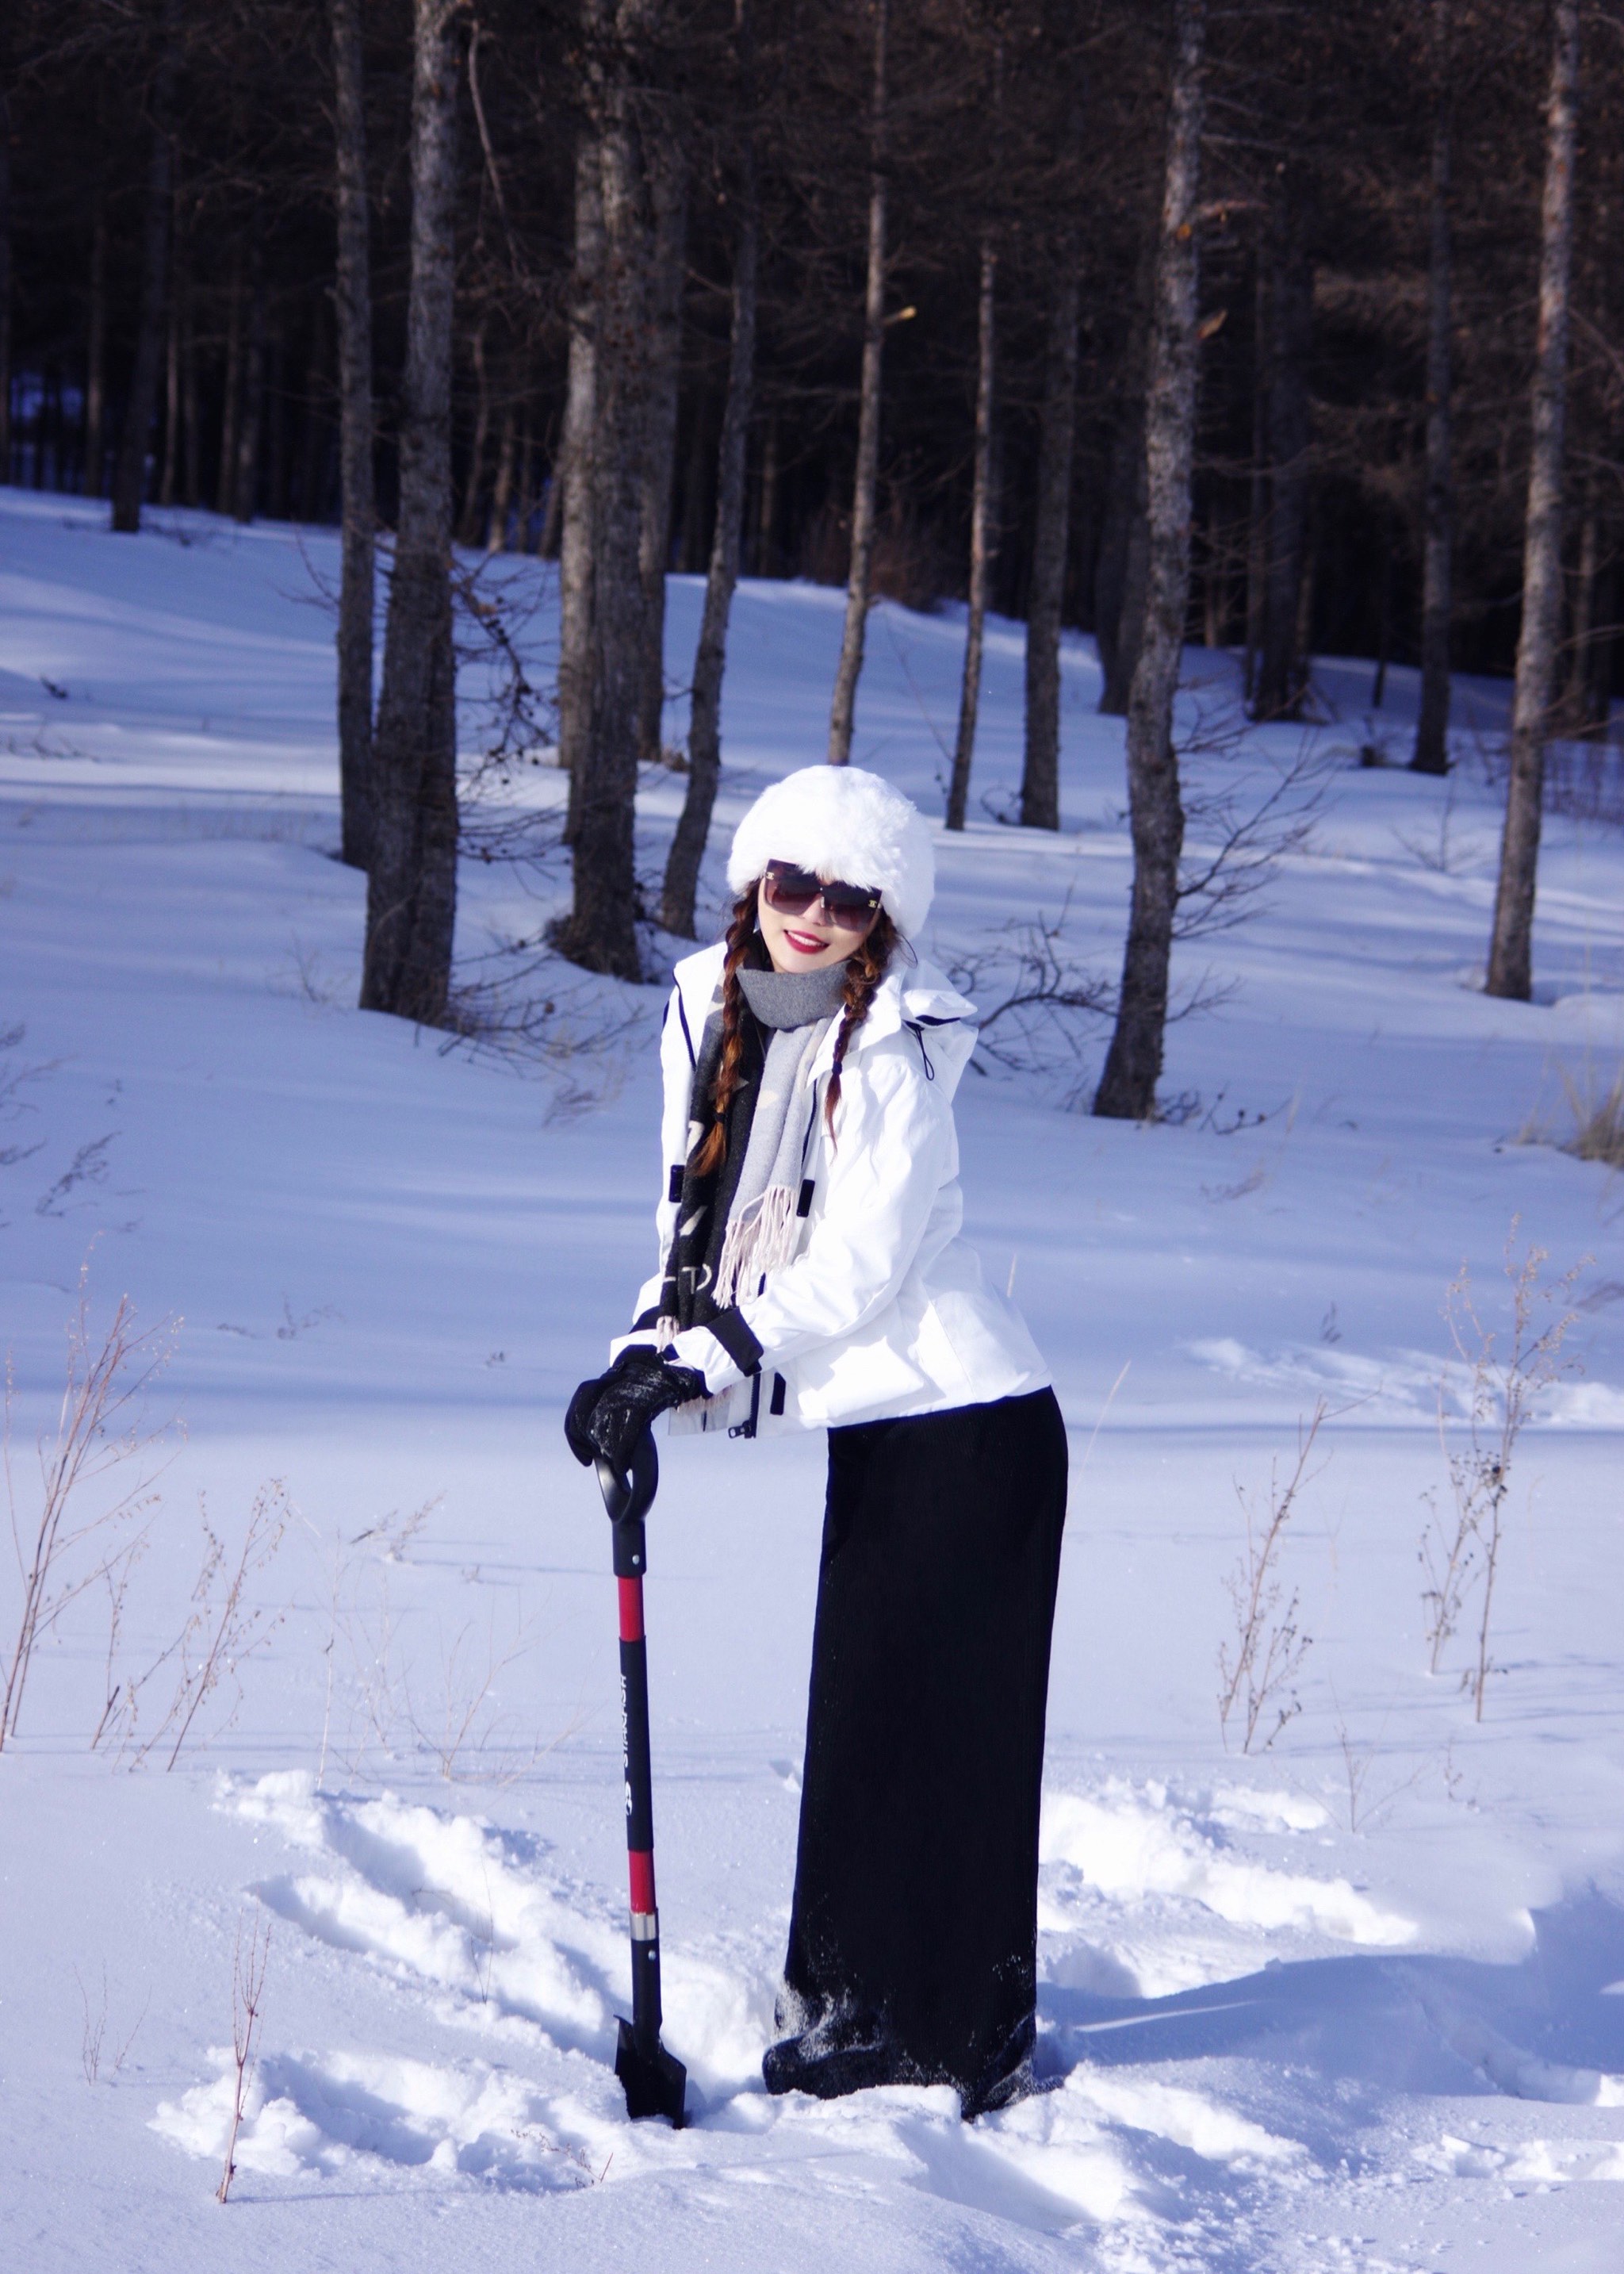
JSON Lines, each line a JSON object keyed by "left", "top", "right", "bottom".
{"left": 1094, "top": 0, "right": 1205, "bottom": 1121}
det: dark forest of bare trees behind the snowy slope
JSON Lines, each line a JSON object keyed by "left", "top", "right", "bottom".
{"left": 0, "top": 0, "right": 1624, "bottom": 1091}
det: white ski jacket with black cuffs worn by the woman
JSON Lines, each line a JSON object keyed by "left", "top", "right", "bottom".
{"left": 612, "top": 941, "right": 1048, "bottom": 1435}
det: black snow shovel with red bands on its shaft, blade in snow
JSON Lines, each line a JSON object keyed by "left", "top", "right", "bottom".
{"left": 598, "top": 1430, "right": 687, "bottom": 2130}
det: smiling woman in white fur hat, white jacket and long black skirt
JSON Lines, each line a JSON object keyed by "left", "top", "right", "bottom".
{"left": 566, "top": 766, "right": 1067, "bottom": 2117}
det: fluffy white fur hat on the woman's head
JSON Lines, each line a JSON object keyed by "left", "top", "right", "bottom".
{"left": 728, "top": 766, "right": 937, "bottom": 939}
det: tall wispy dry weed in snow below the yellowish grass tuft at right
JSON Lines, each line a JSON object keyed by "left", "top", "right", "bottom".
{"left": 1419, "top": 1217, "right": 1592, "bottom": 1721}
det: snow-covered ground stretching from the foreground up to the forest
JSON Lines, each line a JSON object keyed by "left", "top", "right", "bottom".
{"left": 0, "top": 491, "right": 1624, "bottom": 2274}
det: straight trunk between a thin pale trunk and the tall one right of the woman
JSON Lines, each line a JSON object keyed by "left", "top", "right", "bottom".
{"left": 1021, "top": 263, "right": 1080, "bottom": 830}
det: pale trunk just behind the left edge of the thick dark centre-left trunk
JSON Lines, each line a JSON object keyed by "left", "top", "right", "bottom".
{"left": 559, "top": 95, "right": 603, "bottom": 844}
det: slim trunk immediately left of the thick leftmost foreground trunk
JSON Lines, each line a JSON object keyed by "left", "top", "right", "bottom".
{"left": 332, "top": 0, "right": 377, "bottom": 869}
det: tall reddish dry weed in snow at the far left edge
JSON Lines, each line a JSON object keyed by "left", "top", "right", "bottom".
{"left": 0, "top": 1271, "right": 180, "bottom": 1749}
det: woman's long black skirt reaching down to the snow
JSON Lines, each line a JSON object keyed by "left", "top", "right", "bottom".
{"left": 767, "top": 1390, "right": 1067, "bottom": 2115}
